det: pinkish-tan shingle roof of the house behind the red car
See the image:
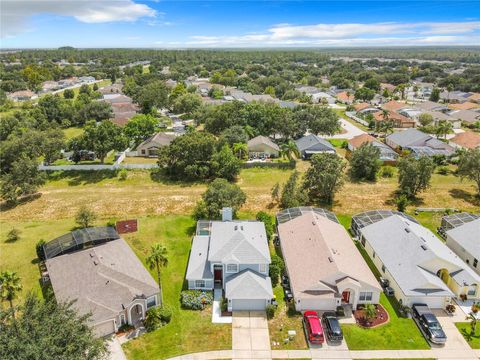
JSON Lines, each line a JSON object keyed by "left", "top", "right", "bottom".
{"left": 278, "top": 210, "right": 379, "bottom": 296}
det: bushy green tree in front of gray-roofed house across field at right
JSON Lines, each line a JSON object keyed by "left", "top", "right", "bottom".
{"left": 397, "top": 156, "right": 435, "bottom": 198}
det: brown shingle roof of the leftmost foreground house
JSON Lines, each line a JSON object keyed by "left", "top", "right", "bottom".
{"left": 46, "top": 239, "right": 159, "bottom": 323}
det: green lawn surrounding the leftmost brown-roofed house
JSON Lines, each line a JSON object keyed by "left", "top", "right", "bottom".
{"left": 0, "top": 216, "right": 231, "bottom": 359}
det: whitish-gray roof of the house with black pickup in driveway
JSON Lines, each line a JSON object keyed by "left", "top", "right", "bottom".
{"left": 360, "top": 214, "right": 480, "bottom": 296}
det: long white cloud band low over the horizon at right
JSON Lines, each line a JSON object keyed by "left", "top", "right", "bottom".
{"left": 186, "top": 21, "right": 480, "bottom": 47}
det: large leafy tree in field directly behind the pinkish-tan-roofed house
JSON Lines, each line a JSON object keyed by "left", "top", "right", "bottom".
{"left": 303, "top": 153, "right": 346, "bottom": 205}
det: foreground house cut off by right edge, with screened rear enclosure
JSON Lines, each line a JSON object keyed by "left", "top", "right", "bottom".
{"left": 442, "top": 213, "right": 480, "bottom": 275}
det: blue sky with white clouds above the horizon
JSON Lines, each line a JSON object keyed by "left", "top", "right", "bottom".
{"left": 0, "top": 0, "right": 480, "bottom": 49}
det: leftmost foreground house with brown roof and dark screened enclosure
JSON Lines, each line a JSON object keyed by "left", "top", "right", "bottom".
{"left": 42, "top": 227, "right": 161, "bottom": 336}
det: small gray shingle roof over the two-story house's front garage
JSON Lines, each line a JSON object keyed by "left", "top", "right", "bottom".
{"left": 225, "top": 269, "right": 273, "bottom": 300}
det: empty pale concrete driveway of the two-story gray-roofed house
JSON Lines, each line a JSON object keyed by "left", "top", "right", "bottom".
{"left": 232, "top": 311, "right": 272, "bottom": 359}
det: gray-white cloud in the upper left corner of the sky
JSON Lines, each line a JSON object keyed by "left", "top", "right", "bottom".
{"left": 0, "top": 0, "right": 157, "bottom": 37}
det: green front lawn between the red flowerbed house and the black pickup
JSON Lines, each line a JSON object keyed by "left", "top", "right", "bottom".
{"left": 342, "top": 243, "right": 429, "bottom": 350}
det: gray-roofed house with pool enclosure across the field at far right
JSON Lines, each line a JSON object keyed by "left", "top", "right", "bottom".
{"left": 385, "top": 129, "right": 454, "bottom": 157}
